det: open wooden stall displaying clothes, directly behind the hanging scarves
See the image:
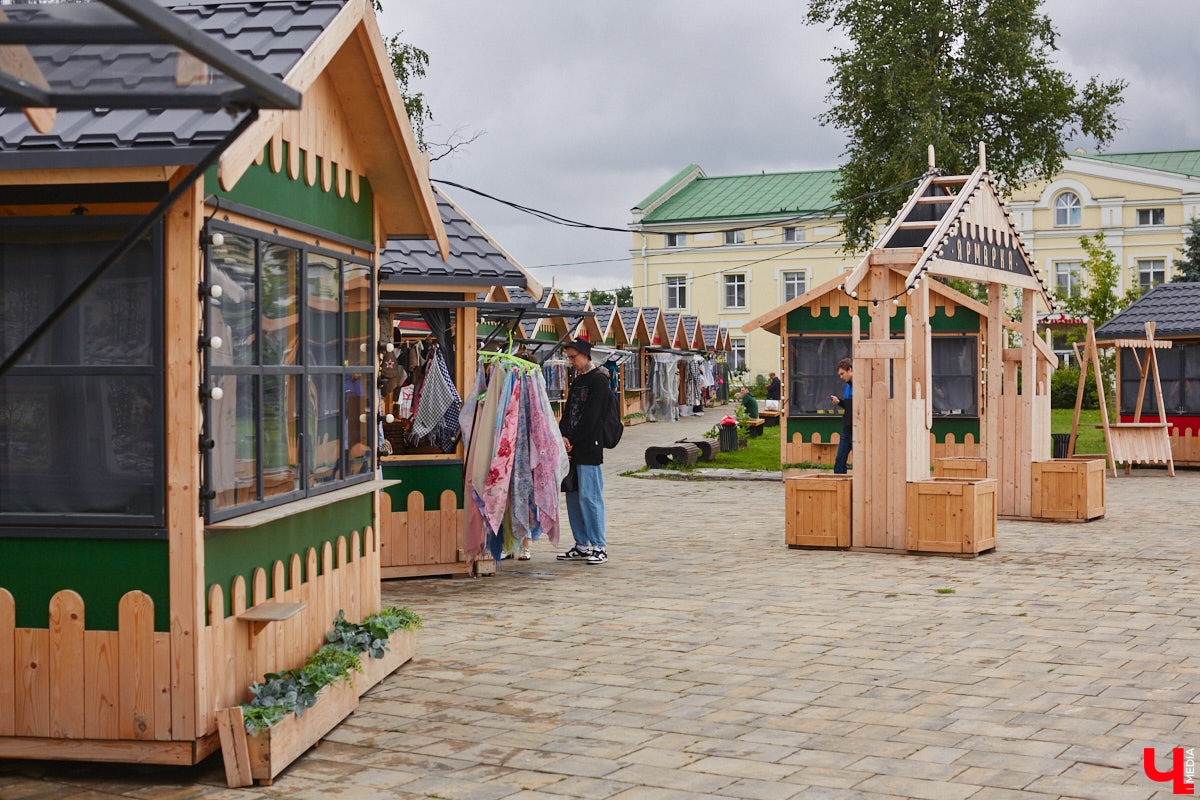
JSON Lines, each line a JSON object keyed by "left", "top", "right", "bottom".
{"left": 379, "top": 190, "right": 542, "bottom": 578}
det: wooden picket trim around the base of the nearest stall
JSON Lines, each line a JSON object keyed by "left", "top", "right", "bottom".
{"left": 0, "top": 528, "right": 380, "bottom": 763}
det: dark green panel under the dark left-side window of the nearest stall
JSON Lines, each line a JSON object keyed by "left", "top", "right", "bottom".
{"left": 0, "top": 537, "right": 170, "bottom": 632}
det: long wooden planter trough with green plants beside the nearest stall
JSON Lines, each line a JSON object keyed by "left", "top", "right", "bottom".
{"left": 217, "top": 630, "right": 416, "bottom": 788}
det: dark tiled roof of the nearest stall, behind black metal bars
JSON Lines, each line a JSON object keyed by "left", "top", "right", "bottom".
{"left": 0, "top": 0, "right": 344, "bottom": 169}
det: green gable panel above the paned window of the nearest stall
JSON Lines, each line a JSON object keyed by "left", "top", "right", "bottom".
{"left": 204, "top": 142, "right": 374, "bottom": 242}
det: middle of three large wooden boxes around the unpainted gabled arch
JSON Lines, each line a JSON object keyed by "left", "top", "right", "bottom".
{"left": 907, "top": 477, "right": 996, "bottom": 557}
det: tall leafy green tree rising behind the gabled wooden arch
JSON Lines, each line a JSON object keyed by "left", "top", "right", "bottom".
{"left": 806, "top": 0, "right": 1126, "bottom": 252}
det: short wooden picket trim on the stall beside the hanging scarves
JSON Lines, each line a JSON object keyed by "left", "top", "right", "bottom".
{"left": 379, "top": 489, "right": 470, "bottom": 578}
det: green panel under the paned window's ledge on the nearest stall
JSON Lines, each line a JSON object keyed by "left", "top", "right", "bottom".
{"left": 204, "top": 493, "right": 374, "bottom": 615}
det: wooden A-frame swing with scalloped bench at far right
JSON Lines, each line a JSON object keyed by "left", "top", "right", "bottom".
{"left": 1068, "top": 320, "right": 1175, "bottom": 477}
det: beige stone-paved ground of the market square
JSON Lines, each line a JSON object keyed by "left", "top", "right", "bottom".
{"left": 0, "top": 411, "right": 1200, "bottom": 800}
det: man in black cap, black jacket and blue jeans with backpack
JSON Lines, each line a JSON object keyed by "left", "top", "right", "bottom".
{"left": 557, "top": 339, "right": 612, "bottom": 564}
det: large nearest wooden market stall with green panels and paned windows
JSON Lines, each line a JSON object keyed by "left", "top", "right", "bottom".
{"left": 0, "top": 0, "right": 446, "bottom": 767}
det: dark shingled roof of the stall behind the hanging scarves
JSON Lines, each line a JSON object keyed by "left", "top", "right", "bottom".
{"left": 379, "top": 190, "right": 533, "bottom": 291}
